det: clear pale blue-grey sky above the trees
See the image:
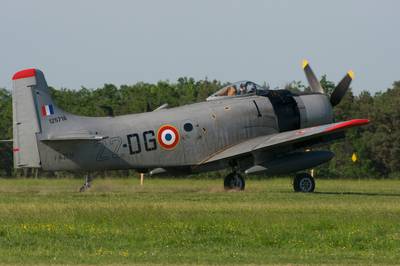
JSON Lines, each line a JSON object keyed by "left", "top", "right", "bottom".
{"left": 0, "top": 0, "right": 400, "bottom": 93}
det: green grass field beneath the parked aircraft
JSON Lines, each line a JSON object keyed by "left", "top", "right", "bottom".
{"left": 0, "top": 178, "right": 400, "bottom": 264}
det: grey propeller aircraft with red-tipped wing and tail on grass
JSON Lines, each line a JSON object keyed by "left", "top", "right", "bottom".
{"left": 12, "top": 61, "right": 369, "bottom": 192}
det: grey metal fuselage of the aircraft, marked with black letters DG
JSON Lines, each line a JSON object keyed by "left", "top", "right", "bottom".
{"left": 37, "top": 94, "right": 332, "bottom": 172}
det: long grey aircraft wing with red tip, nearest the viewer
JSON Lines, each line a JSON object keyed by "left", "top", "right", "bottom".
{"left": 200, "top": 119, "right": 369, "bottom": 164}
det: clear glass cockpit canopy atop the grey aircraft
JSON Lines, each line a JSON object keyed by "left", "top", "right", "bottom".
{"left": 207, "top": 80, "right": 267, "bottom": 101}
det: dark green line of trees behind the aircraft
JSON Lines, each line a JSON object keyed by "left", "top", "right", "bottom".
{"left": 0, "top": 76, "right": 400, "bottom": 178}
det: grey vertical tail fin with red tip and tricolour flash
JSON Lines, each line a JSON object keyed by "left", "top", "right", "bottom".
{"left": 12, "top": 68, "right": 65, "bottom": 168}
